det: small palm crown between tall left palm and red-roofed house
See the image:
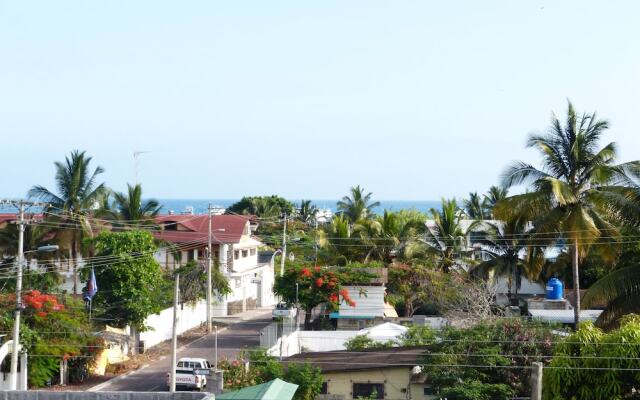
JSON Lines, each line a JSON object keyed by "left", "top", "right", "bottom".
{"left": 104, "top": 184, "right": 162, "bottom": 228}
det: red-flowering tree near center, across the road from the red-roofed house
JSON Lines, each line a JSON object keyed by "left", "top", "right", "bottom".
{"left": 273, "top": 264, "right": 374, "bottom": 329}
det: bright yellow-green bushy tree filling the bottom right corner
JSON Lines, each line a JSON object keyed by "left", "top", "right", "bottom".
{"left": 542, "top": 315, "right": 640, "bottom": 400}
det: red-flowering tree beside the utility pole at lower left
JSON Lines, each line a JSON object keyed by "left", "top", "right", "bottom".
{"left": 0, "top": 290, "right": 97, "bottom": 387}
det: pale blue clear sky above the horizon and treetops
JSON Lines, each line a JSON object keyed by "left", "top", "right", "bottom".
{"left": 0, "top": 0, "right": 640, "bottom": 200}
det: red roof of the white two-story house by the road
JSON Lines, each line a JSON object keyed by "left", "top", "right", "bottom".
{"left": 154, "top": 215, "right": 250, "bottom": 244}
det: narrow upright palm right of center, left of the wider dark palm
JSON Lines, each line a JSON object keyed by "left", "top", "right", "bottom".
{"left": 424, "top": 199, "right": 466, "bottom": 273}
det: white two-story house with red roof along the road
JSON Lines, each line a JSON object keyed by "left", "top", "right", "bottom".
{"left": 154, "top": 215, "right": 275, "bottom": 315}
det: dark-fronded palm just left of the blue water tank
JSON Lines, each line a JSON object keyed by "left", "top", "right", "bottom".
{"left": 469, "top": 214, "right": 545, "bottom": 301}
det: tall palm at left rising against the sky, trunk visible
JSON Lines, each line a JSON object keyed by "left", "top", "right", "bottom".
{"left": 28, "top": 150, "right": 106, "bottom": 293}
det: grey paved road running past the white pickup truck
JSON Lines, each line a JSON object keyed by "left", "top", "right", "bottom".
{"left": 99, "top": 311, "right": 271, "bottom": 392}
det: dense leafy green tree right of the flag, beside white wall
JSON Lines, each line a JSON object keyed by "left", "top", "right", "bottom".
{"left": 93, "top": 231, "right": 165, "bottom": 330}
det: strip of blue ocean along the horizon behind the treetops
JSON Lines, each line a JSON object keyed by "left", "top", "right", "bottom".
{"left": 157, "top": 199, "right": 440, "bottom": 214}
